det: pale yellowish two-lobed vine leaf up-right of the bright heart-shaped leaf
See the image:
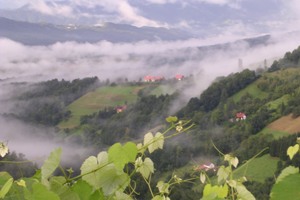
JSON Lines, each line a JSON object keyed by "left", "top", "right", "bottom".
{"left": 144, "top": 132, "right": 164, "bottom": 153}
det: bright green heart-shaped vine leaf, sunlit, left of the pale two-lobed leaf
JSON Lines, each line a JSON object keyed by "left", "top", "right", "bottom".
{"left": 108, "top": 142, "right": 138, "bottom": 170}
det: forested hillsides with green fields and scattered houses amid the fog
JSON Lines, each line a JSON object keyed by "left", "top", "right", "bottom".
{"left": 2, "top": 45, "right": 300, "bottom": 199}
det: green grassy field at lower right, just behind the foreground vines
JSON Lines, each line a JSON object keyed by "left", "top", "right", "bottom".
{"left": 234, "top": 154, "right": 279, "bottom": 183}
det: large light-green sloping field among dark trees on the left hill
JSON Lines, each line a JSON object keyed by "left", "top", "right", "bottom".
{"left": 58, "top": 86, "right": 144, "bottom": 129}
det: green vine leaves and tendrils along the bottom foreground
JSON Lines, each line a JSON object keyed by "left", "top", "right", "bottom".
{"left": 0, "top": 117, "right": 300, "bottom": 200}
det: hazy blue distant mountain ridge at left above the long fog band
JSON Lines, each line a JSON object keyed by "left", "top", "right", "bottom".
{"left": 0, "top": 16, "right": 190, "bottom": 45}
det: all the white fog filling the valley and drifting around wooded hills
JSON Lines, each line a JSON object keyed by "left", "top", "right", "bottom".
{"left": 0, "top": 31, "right": 300, "bottom": 163}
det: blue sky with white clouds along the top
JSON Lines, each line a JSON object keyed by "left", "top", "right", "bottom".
{"left": 0, "top": 0, "right": 300, "bottom": 33}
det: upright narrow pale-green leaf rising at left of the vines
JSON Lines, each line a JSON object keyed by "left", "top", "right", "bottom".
{"left": 41, "top": 148, "right": 62, "bottom": 186}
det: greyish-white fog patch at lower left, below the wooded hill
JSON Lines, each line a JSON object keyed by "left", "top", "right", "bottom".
{"left": 0, "top": 113, "right": 94, "bottom": 166}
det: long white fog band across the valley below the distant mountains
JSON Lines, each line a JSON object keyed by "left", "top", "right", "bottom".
{"left": 0, "top": 33, "right": 299, "bottom": 95}
